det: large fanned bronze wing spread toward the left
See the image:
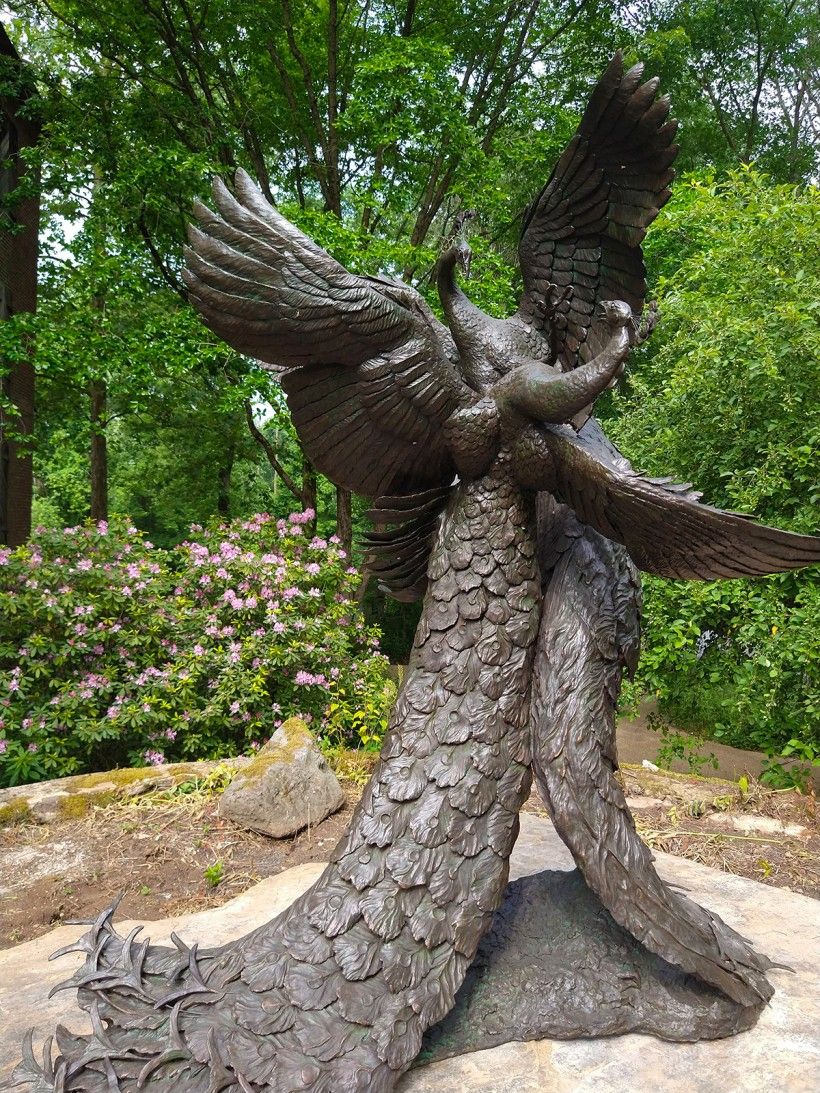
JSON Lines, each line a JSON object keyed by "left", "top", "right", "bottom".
{"left": 184, "top": 171, "right": 468, "bottom": 497}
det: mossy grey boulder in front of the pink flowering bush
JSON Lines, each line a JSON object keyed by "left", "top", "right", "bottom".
{"left": 220, "top": 717, "right": 344, "bottom": 838}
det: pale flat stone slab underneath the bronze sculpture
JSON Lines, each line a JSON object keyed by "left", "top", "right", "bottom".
{"left": 0, "top": 814, "right": 820, "bottom": 1093}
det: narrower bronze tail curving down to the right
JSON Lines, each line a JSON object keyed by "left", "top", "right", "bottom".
{"left": 532, "top": 496, "right": 773, "bottom": 1006}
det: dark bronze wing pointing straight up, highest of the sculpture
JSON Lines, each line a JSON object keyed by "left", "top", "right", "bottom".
{"left": 518, "top": 51, "right": 678, "bottom": 369}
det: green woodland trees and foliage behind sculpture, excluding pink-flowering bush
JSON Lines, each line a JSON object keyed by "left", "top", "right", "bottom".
{"left": 0, "top": 0, "right": 820, "bottom": 780}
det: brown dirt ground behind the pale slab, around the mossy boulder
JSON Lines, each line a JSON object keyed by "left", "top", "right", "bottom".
{"left": 0, "top": 767, "right": 820, "bottom": 949}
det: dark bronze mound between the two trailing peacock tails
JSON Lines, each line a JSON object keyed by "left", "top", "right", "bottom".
{"left": 415, "top": 870, "right": 763, "bottom": 1066}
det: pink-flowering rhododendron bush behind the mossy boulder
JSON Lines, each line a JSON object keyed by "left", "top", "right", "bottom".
{"left": 0, "top": 513, "right": 395, "bottom": 785}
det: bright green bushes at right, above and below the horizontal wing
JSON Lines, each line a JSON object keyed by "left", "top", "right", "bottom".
{"left": 609, "top": 168, "right": 820, "bottom": 753}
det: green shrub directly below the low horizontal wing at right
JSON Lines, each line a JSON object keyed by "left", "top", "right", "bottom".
{"left": 637, "top": 574, "right": 820, "bottom": 754}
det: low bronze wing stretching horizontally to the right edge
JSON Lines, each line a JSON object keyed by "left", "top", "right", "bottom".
{"left": 542, "top": 421, "right": 820, "bottom": 580}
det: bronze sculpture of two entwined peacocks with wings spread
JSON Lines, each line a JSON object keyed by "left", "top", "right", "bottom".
{"left": 6, "top": 56, "right": 820, "bottom": 1093}
